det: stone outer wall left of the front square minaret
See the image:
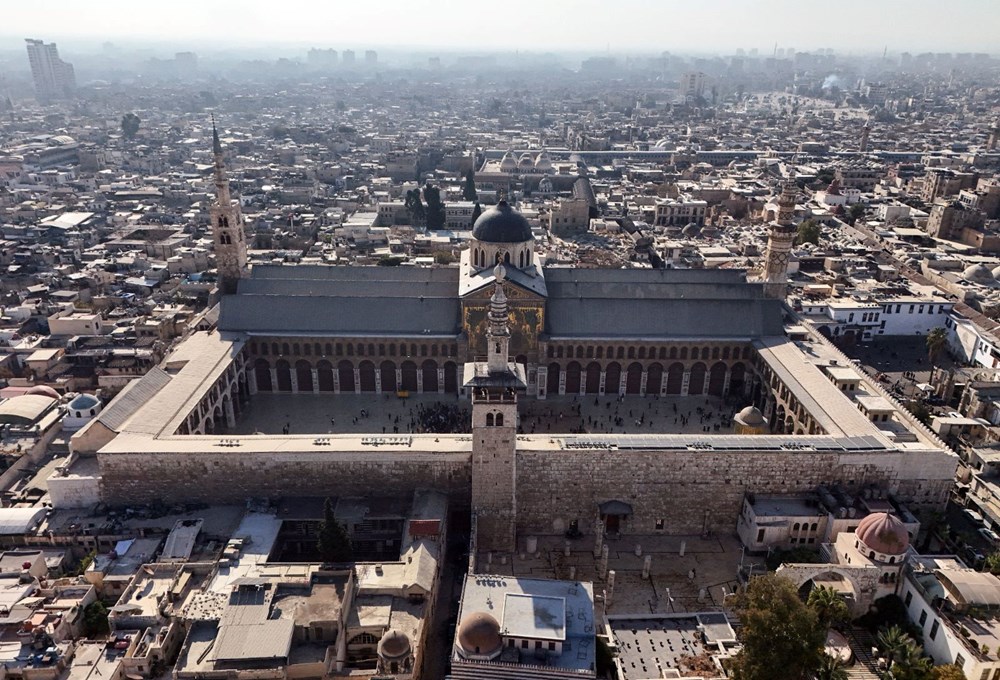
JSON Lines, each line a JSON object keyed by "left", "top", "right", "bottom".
{"left": 97, "top": 451, "right": 471, "bottom": 505}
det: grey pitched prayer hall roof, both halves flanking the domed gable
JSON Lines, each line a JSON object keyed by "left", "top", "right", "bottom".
{"left": 219, "top": 265, "right": 783, "bottom": 339}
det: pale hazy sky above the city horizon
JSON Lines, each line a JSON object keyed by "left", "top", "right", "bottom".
{"left": 7, "top": 0, "right": 1000, "bottom": 52}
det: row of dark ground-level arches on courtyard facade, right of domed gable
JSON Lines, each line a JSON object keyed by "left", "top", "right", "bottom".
{"left": 546, "top": 361, "right": 746, "bottom": 396}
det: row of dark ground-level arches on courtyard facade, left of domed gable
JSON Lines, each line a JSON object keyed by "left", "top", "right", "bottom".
{"left": 254, "top": 357, "right": 458, "bottom": 394}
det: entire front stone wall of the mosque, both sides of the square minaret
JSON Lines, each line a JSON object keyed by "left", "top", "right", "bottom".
{"left": 98, "top": 450, "right": 957, "bottom": 536}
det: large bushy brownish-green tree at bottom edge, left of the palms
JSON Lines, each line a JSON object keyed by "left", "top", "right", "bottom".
{"left": 731, "top": 574, "right": 826, "bottom": 680}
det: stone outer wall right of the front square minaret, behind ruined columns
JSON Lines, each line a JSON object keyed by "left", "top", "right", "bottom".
{"left": 517, "top": 451, "right": 958, "bottom": 536}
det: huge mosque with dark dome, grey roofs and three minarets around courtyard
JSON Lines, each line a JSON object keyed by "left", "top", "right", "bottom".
{"left": 73, "top": 130, "right": 956, "bottom": 550}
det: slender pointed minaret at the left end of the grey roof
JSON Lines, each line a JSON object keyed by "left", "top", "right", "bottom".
{"left": 209, "top": 116, "right": 247, "bottom": 295}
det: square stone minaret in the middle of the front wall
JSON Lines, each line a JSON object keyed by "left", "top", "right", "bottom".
{"left": 466, "top": 264, "right": 524, "bottom": 552}
